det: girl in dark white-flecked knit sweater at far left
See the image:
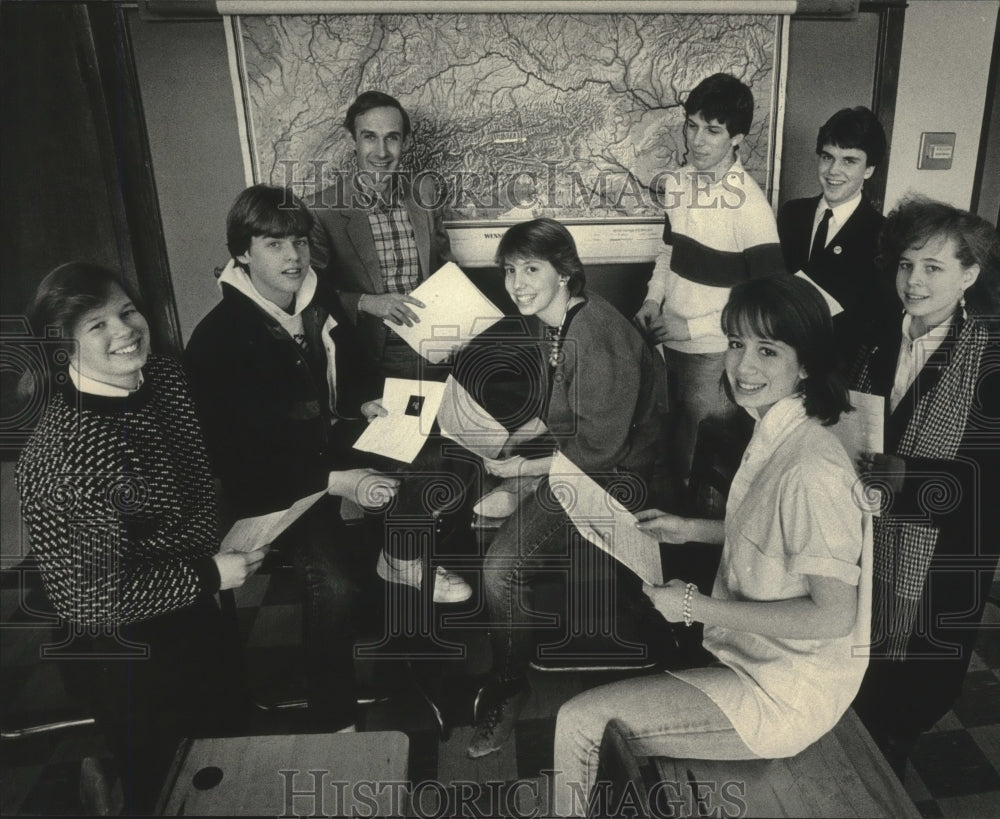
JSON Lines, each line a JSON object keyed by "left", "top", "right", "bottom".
{"left": 17, "top": 262, "right": 264, "bottom": 813}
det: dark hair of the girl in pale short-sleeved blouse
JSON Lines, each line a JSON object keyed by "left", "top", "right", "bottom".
{"left": 722, "top": 276, "right": 851, "bottom": 426}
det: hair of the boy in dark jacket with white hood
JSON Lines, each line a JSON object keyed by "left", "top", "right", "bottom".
{"left": 226, "top": 185, "right": 314, "bottom": 259}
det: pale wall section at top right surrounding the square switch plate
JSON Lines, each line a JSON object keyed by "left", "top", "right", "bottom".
{"left": 885, "top": 0, "right": 1000, "bottom": 210}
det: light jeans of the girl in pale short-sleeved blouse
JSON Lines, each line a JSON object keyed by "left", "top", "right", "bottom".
{"left": 552, "top": 665, "right": 758, "bottom": 816}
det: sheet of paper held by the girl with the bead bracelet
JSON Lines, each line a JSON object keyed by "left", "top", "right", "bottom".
{"left": 549, "top": 452, "right": 663, "bottom": 586}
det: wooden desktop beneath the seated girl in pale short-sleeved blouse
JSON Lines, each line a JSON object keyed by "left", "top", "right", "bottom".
{"left": 656, "top": 709, "right": 920, "bottom": 817}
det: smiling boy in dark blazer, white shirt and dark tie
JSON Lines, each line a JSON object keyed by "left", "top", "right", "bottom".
{"left": 778, "top": 106, "right": 901, "bottom": 366}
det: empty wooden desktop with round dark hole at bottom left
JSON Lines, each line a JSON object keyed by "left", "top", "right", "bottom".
{"left": 157, "top": 731, "right": 409, "bottom": 816}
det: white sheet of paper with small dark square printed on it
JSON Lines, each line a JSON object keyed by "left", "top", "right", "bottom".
{"left": 354, "top": 378, "right": 444, "bottom": 464}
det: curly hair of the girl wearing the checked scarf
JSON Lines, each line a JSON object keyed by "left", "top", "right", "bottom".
{"left": 878, "top": 195, "right": 1000, "bottom": 315}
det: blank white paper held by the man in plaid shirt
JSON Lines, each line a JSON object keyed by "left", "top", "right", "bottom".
{"left": 384, "top": 262, "right": 503, "bottom": 364}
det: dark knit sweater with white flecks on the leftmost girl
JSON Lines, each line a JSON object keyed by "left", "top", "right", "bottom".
{"left": 17, "top": 356, "right": 219, "bottom": 627}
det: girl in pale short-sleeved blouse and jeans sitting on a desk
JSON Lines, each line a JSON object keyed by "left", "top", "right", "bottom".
{"left": 553, "top": 277, "right": 871, "bottom": 815}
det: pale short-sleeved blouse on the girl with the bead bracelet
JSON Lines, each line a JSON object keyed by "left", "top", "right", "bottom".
{"left": 676, "top": 396, "right": 872, "bottom": 758}
